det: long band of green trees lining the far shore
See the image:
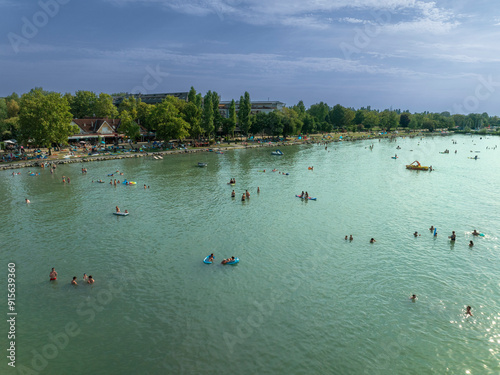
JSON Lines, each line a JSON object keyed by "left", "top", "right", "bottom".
{"left": 0, "top": 87, "right": 500, "bottom": 147}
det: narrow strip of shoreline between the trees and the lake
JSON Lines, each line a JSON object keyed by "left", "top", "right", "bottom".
{"left": 0, "top": 133, "right": 438, "bottom": 171}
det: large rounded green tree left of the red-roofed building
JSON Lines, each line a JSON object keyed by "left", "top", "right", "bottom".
{"left": 19, "top": 89, "right": 77, "bottom": 154}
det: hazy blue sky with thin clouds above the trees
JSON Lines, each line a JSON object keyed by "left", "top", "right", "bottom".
{"left": 0, "top": 0, "right": 500, "bottom": 115}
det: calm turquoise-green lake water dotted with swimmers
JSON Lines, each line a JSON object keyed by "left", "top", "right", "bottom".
{"left": 0, "top": 136, "right": 500, "bottom": 374}
